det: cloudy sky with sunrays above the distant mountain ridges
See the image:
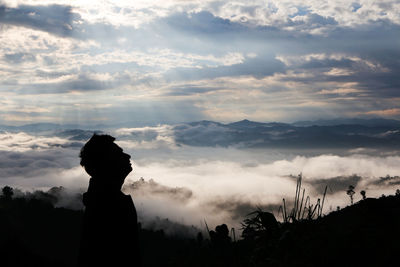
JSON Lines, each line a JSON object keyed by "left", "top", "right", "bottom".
{"left": 0, "top": 0, "right": 400, "bottom": 125}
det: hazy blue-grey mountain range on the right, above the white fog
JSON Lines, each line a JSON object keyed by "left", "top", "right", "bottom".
{"left": 174, "top": 120, "right": 400, "bottom": 148}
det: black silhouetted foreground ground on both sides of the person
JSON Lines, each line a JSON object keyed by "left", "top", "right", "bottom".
{"left": 0, "top": 192, "right": 400, "bottom": 267}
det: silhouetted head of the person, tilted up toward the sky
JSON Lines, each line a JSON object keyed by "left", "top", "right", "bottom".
{"left": 79, "top": 134, "right": 132, "bottom": 186}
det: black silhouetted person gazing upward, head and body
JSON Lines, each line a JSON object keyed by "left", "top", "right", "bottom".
{"left": 78, "top": 134, "right": 140, "bottom": 267}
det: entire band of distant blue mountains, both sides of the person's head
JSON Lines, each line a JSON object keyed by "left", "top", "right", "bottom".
{"left": 0, "top": 119, "right": 400, "bottom": 149}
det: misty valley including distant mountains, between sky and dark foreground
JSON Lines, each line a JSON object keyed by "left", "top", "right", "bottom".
{"left": 0, "top": 119, "right": 400, "bottom": 231}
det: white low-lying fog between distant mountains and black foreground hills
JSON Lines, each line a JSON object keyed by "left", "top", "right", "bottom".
{"left": 0, "top": 127, "right": 400, "bottom": 234}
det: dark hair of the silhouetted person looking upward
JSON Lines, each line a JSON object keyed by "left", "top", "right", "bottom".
{"left": 79, "top": 134, "right": 115, "bottom": 176}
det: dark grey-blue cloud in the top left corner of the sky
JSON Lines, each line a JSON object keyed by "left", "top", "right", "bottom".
{"left": 0, "top": 5, "right": 79, "bottom": 37}
